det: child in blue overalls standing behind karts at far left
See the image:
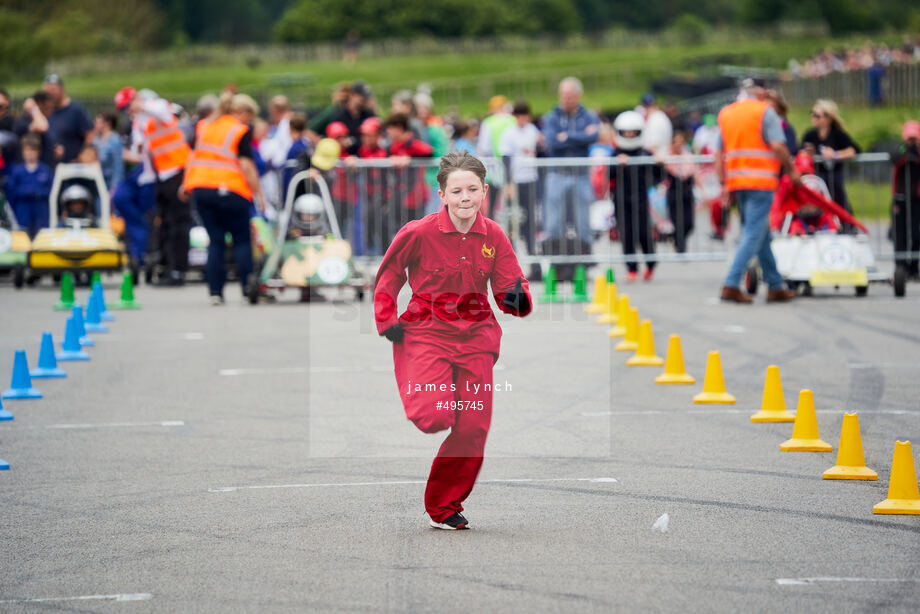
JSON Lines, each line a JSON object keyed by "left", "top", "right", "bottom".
{"left": 4, "top": 134, "right": 53, "bottom": 238}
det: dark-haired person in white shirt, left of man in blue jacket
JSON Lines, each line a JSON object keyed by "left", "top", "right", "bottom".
{"left": 499, "top": 102, "right": 544, "bottom": 254}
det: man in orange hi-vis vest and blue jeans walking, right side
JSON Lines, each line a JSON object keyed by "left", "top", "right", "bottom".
{"left": 716, "top": 80, "right": 802, "bottom": 303}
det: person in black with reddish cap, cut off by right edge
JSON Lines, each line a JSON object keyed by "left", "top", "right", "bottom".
{"left": 891, "top": 121, "right": 920, "bottom": 280}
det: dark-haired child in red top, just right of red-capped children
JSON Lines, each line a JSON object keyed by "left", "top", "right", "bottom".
{"left": 384, "top": 113, "right": 434, "bottom": 228}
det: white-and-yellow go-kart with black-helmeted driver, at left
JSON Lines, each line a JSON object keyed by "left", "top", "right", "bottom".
{"left": 28, "top": 164, "right": 128, "bottom": 275}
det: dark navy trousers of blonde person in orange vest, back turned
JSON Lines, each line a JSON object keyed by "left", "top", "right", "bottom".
{"left": 192, "top": 189, "right": 252, "bottom": 296}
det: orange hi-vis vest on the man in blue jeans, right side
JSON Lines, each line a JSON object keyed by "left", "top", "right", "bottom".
{"left": 719, "top": 100, "right": 781, "bottom": 192}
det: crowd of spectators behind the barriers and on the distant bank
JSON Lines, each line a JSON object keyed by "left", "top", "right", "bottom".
{"left": 0, "top": 71, "right": 918, "bottom": 292}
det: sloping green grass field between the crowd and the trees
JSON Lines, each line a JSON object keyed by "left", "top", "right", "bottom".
{"left": 10, "top": 33, "right": 908, "bottom": 115}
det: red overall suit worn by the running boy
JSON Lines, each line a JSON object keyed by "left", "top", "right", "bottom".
{"left": 374, "top": 206, "right": 532, "bottom": 522}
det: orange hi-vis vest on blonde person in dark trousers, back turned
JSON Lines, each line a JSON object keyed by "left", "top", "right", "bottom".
{"left": 185, "top": 115, "right": 252, "bottom": 200}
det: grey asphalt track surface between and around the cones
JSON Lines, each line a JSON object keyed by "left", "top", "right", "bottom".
{"left": 0, "top": 263, "right": 920, "bottom": 613}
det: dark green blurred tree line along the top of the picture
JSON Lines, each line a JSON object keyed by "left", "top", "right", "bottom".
{"left": 0, "top": 0, "right": 920, "bottom": 79}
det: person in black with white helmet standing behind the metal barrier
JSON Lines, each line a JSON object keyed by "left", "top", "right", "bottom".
{"left": 610, "top": 111, "right": 660, "bottom": 282}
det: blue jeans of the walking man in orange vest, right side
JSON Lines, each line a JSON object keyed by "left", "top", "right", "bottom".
{"left": 725, "top": 190, "right": 785, "bottom": 290}
